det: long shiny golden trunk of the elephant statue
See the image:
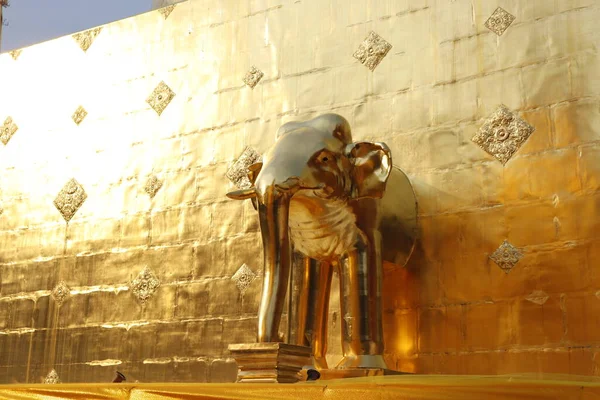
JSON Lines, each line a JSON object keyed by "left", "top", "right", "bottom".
{"left": 257, "top": 184, "right": 292, "bottom": 342}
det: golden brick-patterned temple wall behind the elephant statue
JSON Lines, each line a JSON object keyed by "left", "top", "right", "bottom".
{"left": 0, "top": 0, "right": 600, "bottom": 383}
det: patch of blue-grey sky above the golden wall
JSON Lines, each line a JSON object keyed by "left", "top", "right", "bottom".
{"left": 2, "top": 0, "right": 152, "bottom": 52}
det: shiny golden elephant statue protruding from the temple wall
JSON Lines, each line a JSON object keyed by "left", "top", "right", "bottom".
{"left": 228, "top": 114, "right": 416, "bottom": 369}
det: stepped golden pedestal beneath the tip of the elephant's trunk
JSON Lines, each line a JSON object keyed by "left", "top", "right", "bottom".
{"left": 229, "top": 343, "right": 311, "bottom": 383}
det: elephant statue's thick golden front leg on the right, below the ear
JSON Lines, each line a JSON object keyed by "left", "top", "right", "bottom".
{"left": 337, "top": 234, "right": 387, "bottom": 368}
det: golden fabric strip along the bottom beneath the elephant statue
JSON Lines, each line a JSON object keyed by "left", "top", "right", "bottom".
{"left": 0, "top": 375, "right": 600, "bottom": 400}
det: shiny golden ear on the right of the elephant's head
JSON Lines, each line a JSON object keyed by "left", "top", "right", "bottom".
{"left": 346, "top": 142, "right": 392, "bottom": 199}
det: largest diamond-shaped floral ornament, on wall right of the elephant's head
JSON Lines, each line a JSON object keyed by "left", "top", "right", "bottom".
{"left": 471, "top": 105, "right": 535, "bottom": 164}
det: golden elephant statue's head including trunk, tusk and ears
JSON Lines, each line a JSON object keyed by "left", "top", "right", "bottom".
{"left": 227, "top": 114, "right": 392, "bottom": 342}
